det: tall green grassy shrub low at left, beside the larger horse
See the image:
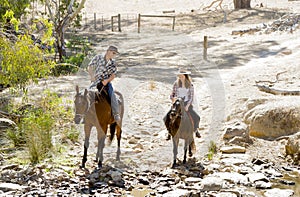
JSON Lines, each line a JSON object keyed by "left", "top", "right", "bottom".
{"left": 7, "top": 90, "right": 79, "bottom": 163}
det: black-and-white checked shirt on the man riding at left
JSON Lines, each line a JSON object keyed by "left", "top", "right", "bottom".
{"left": 89, "top": 55, "right": 117, "bottom": 85}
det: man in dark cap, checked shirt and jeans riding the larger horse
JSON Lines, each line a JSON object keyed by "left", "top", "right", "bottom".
{"left": 88, "top": 46, "right": 121, "bottom": 125}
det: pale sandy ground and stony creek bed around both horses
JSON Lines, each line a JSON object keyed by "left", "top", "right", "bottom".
{"left": 0, "top": 1, "right": 300, "bottom": 197}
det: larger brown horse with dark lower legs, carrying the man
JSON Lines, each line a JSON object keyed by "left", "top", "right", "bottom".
{"left": 74, "top": 86, "right": 124, "bottom": 168}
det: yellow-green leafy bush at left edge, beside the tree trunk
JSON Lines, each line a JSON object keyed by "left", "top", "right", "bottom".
{"left": 0, "top": 35, "right": 53, "bottom": 92}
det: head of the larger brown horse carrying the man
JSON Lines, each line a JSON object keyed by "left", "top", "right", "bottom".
{"left": 74, "top": 86, "right": 90, "bottom": 124}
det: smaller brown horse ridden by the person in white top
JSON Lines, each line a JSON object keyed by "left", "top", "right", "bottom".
{"left": 165, "top": 98, "right": 196, "bottom": 168}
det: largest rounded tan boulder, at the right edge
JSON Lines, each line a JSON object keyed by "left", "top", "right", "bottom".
{"left": 244, "top": 97, "right": 300, "bottom": 140}
